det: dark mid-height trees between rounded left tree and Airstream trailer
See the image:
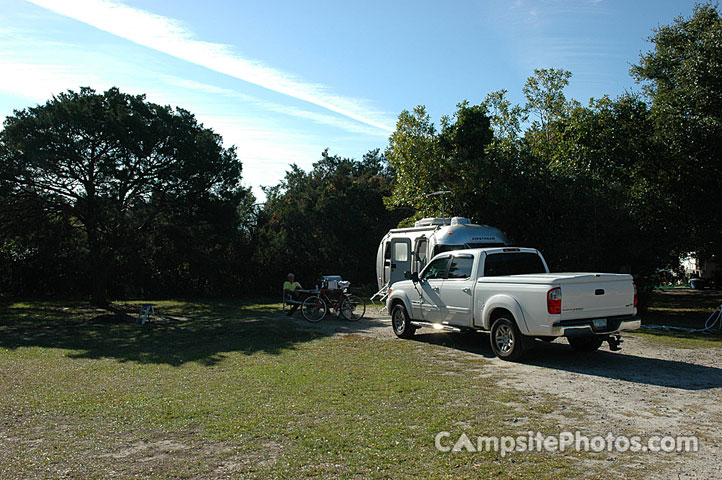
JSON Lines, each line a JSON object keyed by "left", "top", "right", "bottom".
{"left": 257, "top": 150, "right": 402, "bottom": 291}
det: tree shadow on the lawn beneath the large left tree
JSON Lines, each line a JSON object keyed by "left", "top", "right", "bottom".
{"left": 0, "top": 301, "right": 323, "bottom": 366}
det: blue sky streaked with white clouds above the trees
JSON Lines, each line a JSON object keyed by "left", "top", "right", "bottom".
{"left": 0, "top": 0, "right": 694, "bottom": 197}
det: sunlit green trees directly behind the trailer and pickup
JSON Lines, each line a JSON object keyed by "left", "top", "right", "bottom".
{"left": 388, "top": 69, "right": 681, "bottom": 294}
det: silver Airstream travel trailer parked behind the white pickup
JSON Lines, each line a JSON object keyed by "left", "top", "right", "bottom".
{"left": 376, "top": 217, "right": 509, "bottom": 295}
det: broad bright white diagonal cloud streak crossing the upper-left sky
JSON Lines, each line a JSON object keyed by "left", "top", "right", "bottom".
{"left": 27, "top": 0, "right": 393, "bottom": 133}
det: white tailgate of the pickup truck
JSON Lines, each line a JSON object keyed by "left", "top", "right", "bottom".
{"left": 558, "top": 274, "right": 634, "bottom": 320}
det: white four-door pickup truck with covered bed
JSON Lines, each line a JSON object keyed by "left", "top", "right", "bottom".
{"left": 386, "top": 247, "right": 641, "bottom": 361}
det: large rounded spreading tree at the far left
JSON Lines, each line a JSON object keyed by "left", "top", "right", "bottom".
{"left": 0, "top": 88, "right": 250, "bottom": 304}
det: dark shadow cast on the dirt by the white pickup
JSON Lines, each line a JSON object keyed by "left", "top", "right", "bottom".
{"left": 413, "top": 330, "right": 722, "bottom": 390}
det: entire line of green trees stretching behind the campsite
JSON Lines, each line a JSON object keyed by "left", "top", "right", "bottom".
{"left": 0, "top": 4, "right": 722, "bottom": 303}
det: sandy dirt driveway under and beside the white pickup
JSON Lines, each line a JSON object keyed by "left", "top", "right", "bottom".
{"left": 286, "top": 308, "right": 722, "bottom": 479}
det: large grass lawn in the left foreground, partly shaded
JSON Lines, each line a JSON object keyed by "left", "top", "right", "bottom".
{"left": 0, "top": 301, "right": 623, "bottom": 479}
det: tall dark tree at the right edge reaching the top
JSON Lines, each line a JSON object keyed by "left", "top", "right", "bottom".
{"left": 632, "top": 3, "right": 722, "bottom": 257}
